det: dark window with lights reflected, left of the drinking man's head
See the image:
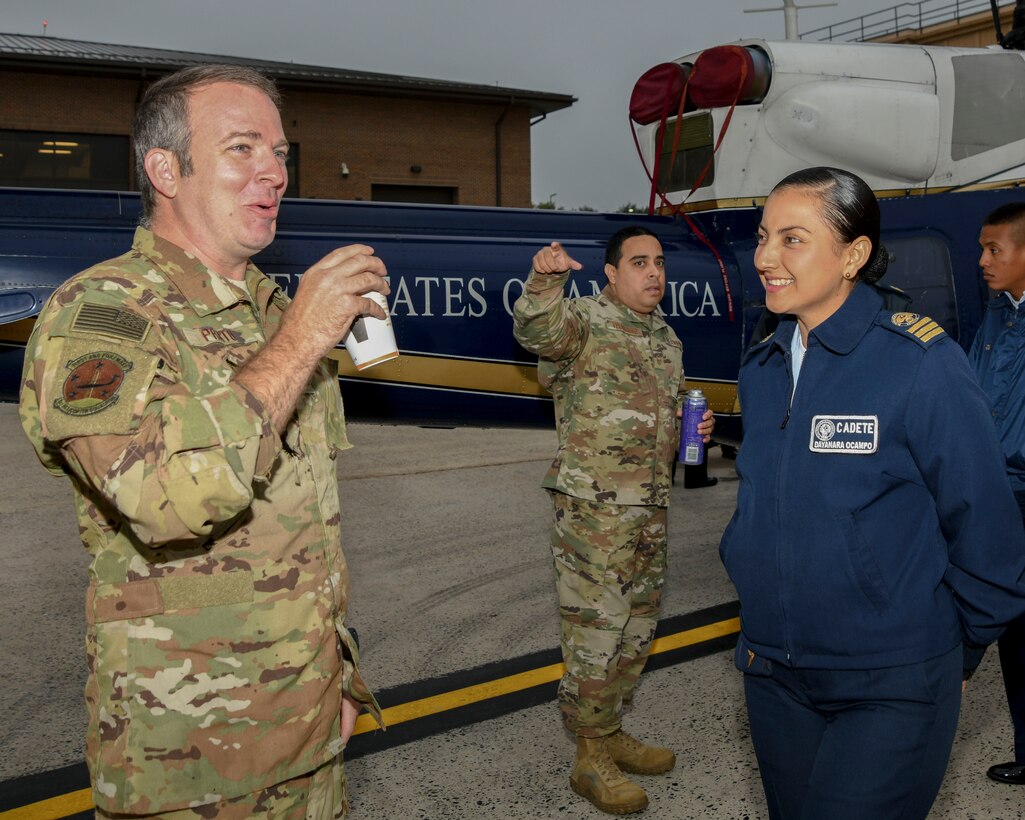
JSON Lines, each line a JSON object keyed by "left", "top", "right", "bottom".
{"left": 0, "top": 130, "right": 130, "bottom": 191}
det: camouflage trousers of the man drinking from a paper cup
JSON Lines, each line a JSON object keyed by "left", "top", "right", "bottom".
{"left": 96, "top": 754, "right": 349, "bottom": 820}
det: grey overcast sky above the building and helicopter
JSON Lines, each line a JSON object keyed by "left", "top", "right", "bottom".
{"left": 0, "top": 0, "right": 967, "bottom": 210}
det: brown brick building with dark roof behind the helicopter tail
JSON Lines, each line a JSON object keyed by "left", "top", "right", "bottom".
{"left": 0, "top": 34, "right": 575, "bottom": 207}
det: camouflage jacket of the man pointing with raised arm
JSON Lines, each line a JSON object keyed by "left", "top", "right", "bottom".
{"left": 513, "top": 272, "right": 684, "bottom": 506}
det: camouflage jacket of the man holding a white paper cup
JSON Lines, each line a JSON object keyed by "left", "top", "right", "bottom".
{"left": 21, "top": 229, "right": 377, "bottom": 814}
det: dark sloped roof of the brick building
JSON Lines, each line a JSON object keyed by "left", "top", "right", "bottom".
{"left": 0, "top": 33, "right": 576, "bottom": 116}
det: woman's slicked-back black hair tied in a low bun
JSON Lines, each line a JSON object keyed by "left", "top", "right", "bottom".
{"left": 770, "top": 166, "right": 890, "bottom": 284}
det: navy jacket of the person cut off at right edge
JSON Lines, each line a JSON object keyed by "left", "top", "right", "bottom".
{"left": 968, "top": 293, "right": 1025, "bottom": 494}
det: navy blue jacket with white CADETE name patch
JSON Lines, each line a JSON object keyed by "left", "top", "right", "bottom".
{"left": 720, "top": 285, "right": 1025, "bottom": 669}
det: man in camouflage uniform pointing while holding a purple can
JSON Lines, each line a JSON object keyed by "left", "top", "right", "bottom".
{"left": 514, "top": 227, "right": 712, "bottom": 814}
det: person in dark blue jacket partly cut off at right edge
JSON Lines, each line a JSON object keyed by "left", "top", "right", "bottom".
{"left": 969, "top": 202, "right": 1025, "bottom": 784}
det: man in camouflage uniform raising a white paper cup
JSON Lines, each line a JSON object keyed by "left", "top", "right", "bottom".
{"left": 22, "top": 66, "right": 387, "bottom": 818}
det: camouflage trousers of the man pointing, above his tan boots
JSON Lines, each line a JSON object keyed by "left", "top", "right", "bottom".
{"left": 550, "top": 492, "right": 666, "bottom": 737}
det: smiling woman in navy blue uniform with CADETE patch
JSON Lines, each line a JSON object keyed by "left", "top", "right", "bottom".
{"left": 720, "top": 168, "right": 1025, "bottom": 820}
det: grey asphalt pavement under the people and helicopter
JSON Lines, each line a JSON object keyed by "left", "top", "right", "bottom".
{"left": 0, "top": 404, "right": 1025, "bottom": 820}
